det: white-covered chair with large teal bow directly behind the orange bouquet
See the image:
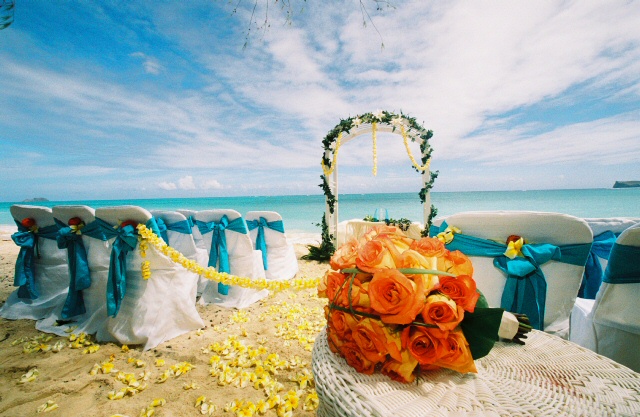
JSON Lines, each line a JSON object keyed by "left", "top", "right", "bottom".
{"left": 431, "top": 211, "right": 593, "bottom": 338}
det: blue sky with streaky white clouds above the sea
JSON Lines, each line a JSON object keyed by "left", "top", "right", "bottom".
{"left": 0, "top": 0, "right": 640, "bottom": 201}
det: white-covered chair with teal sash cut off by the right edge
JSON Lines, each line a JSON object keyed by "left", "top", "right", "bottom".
{"left": 570, "top": 223, "right": 640, "bottom": 372}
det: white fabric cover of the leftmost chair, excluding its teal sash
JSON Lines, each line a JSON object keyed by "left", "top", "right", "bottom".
{"left": 0, "top": 205, "right": 69, "bottom": 320}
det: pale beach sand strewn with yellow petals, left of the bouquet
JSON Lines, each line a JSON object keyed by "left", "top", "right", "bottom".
{"left": 0, "top": 240, "right": 328, "bottom": 417}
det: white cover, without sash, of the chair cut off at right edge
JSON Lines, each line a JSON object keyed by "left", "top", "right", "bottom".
{"left": 570, "top": 223, "right": 640, "bottom": 372}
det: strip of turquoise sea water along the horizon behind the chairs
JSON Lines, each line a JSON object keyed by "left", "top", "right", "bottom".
{"left": 0, "top": 188, "right": 640, "bottom": 232}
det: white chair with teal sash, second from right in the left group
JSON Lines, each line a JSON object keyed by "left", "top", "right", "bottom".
{"left": 196, "top": 210, "right": 268, "bottom": 308}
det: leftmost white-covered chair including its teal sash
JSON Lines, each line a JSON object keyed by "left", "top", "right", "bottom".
{"left": 0, "top": 205, "right": 69, "bottom": 320}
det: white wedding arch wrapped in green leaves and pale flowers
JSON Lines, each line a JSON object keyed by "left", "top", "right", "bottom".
{"left": 320, "top": 110, "right": 438, "bottom": 252}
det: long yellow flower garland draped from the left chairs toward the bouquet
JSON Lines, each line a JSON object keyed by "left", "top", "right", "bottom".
{"left": 138, "top": 224, "right": 320, "bottom": 292}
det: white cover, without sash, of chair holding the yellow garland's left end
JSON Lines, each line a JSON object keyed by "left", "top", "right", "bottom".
{"left": 51, "top": 206, "right": 204, "bottom": 350}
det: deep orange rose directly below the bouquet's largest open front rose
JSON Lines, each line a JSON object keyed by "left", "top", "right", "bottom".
{"left": 352, "top": 317, "right": 402, "bottom": 363}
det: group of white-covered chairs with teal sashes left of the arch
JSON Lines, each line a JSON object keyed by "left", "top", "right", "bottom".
{"left": 0, "top": 205, "right": 298, "bottom": 349}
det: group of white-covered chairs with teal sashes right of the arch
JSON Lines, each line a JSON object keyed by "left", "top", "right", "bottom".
{"left": 431, "top": 211, "right": 640, "bottom": 371}
